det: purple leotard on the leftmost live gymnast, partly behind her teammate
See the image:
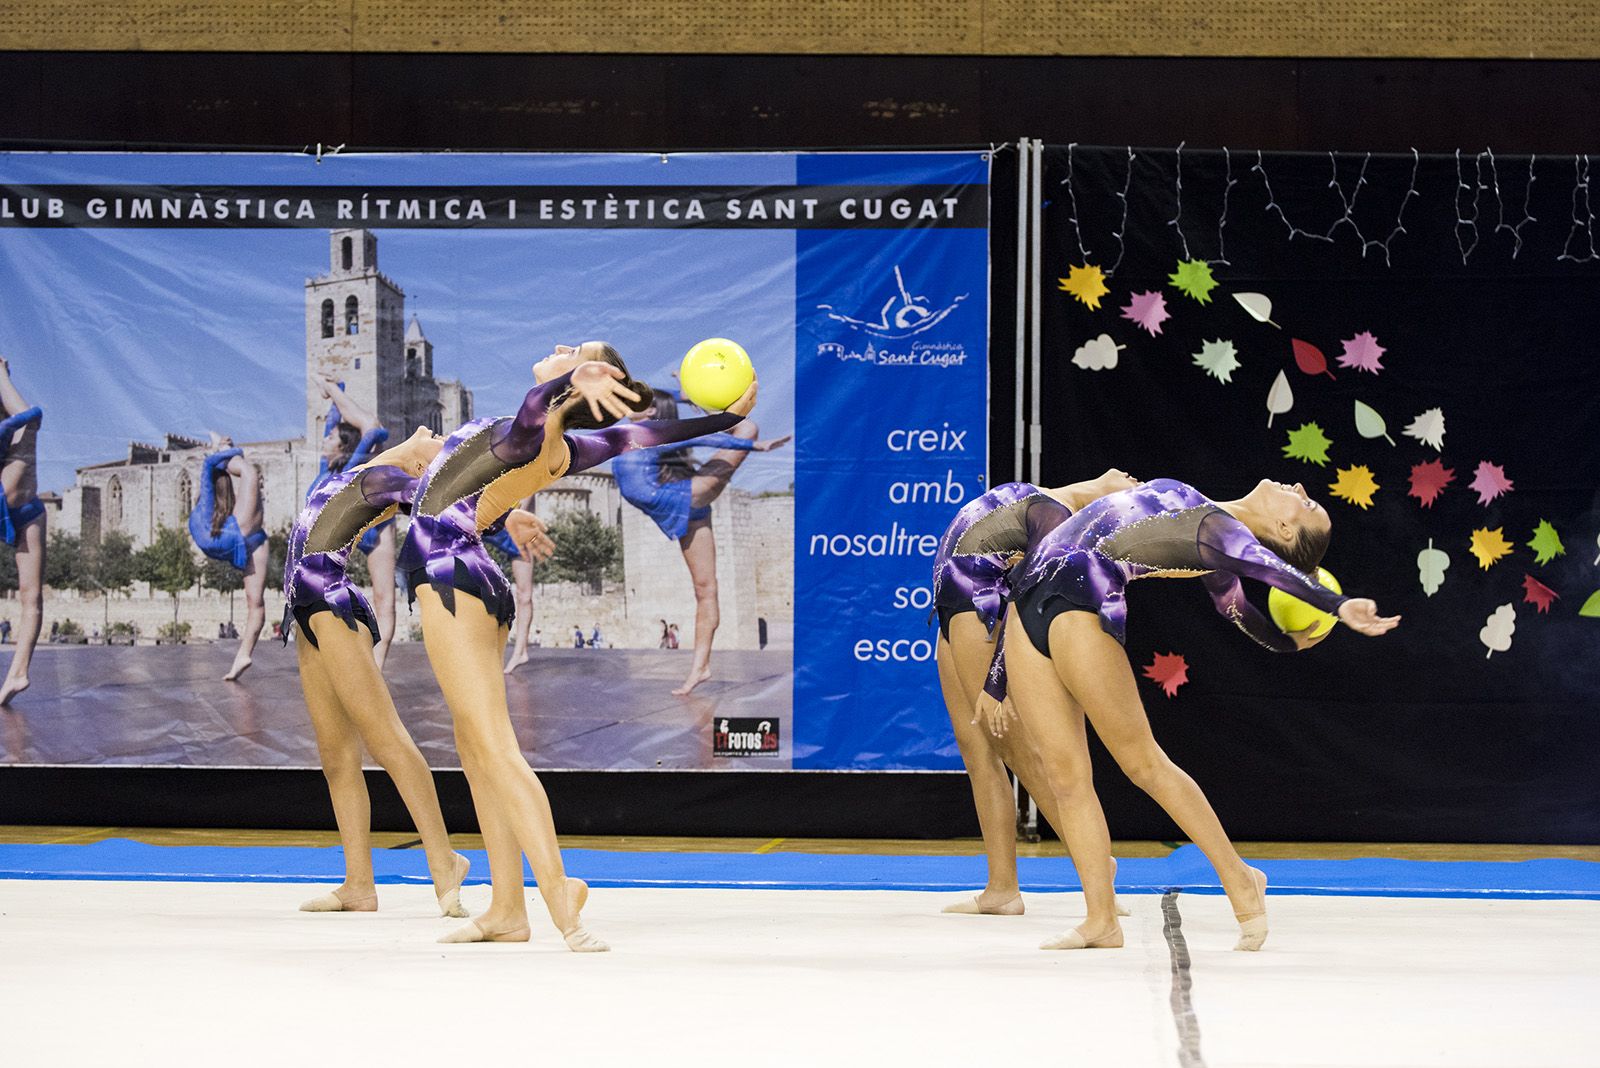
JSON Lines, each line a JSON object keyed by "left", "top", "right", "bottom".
{"left": 283, "top": 465, "right": 416, "bottom": 646}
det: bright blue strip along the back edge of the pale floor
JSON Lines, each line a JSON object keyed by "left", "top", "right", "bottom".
{"left": 0, "top": 838, "right": 1600, "bottom": 900}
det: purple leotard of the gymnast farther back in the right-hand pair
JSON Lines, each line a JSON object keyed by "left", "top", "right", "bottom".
{"left": 933, "top": 483, "right": 1072, "bottom": 640}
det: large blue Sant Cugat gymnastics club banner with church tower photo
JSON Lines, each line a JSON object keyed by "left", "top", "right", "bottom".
{"left": 0, "top": 152, "right": 989, "bottom": 771}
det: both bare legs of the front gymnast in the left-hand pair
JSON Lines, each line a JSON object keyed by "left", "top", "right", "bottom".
{"left": 418, "top": 585, "right": 610, "bottom": 951}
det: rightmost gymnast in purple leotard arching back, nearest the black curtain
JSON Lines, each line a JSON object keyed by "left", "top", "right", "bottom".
{"left": 966, "top": 478, "right": 1400, "bottom": 950}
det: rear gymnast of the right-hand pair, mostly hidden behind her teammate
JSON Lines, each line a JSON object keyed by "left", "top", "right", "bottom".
{"left": 933, "top": 468, "right": 1138, "bottom": 916}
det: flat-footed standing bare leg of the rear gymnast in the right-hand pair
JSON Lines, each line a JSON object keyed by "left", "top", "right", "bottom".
{"left": 934, "top": 612, "right": 1022, "bottom": 916}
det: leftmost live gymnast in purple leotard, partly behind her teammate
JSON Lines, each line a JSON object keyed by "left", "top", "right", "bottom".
{"left": 283, "top": 427, "right": 515, "bottom": 918}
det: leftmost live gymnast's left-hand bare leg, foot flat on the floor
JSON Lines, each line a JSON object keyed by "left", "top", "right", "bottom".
{"left": 294, "top": 638, "right": 378, "bottom": 913}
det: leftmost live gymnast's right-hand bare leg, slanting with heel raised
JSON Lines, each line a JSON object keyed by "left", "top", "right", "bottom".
{"left": 307, "top": 612, "right": 467, "bottom": 916}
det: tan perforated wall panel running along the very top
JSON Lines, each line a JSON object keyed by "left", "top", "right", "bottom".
{"left": 0, "top": 0, "right": 1600, "bottom": 59}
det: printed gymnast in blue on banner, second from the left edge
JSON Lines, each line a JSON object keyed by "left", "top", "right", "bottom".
{"left": 189, "top": 433, "right": 267, "bottom": 683}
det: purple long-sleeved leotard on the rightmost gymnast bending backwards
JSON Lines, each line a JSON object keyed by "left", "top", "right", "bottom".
{"left": 984, "top": 478, "right": 1349, "bottom": 699}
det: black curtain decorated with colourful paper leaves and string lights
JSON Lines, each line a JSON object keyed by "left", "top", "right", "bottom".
{"left": 1042, "top": 145, "right": 1600, "bottom": 843}
